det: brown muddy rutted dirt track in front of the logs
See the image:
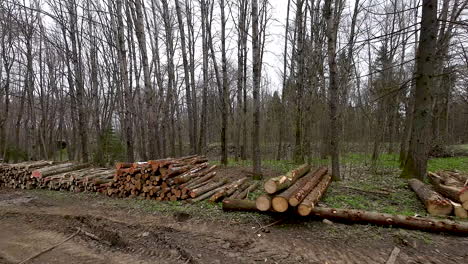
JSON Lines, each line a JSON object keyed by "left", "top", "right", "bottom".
{"left": 0, "top": 189, "right": 468, "bottom": 264}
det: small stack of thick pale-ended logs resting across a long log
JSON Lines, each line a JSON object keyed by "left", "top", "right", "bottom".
{"left": 255, "top": 164, "right": 331, "bottom": 216}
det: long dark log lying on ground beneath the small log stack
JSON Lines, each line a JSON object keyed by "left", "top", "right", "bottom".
{"left": 223, "top": 199, "right": 468, "bottom": 235}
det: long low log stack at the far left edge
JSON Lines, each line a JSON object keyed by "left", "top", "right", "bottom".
{"left": 0, "top": 161, "right": 115, "bottom": 192}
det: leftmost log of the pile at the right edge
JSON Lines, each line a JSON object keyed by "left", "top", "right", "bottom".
{"left": 409, "top": 179, "right": 453, "bottom": 216}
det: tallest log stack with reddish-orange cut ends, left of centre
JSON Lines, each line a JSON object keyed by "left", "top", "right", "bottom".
{"left": 107, "top": 155, "right": 252, "bottom": 202}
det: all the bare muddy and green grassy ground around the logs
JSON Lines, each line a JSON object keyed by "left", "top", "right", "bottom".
{"left": 0, "top": 156, "right": 468, "bottom": 264}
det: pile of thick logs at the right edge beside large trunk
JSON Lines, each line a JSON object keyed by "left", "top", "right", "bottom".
{"left": 410, "top": 171, "right": 468, "bottom": 218}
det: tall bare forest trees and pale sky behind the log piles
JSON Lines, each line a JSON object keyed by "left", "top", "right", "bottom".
{"left": 0, "top": 0, "right": 468, "bottom": 180}
